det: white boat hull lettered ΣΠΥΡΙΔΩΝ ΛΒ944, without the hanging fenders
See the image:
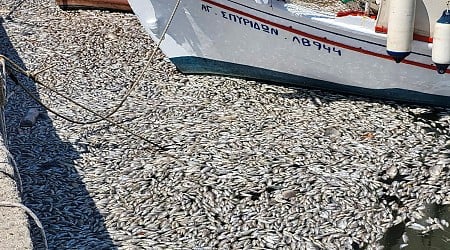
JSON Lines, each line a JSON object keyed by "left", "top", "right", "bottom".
{"left": 129, "top": 0, "right": 450, "bottom": 106}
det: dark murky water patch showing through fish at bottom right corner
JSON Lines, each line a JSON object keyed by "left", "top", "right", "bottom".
{"left": 382, "top": 204, "right": 450, "bottom": 250}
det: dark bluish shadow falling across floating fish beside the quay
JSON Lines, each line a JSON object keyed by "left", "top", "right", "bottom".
{"left": 0, "top": 17, "right": 116, "bottom": 249}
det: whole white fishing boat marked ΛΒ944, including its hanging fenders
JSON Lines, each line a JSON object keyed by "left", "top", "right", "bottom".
{"left": 129, "top": 0, "right": 450, "bottom": 107}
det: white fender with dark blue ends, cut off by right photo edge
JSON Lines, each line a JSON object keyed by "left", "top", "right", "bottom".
{"left": 431, "top": 10, "right": 450, "bottom": 74}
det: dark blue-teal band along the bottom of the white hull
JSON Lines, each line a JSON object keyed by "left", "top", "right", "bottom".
{"left": 170, "top": 56, "right": 450, "bottom": 107}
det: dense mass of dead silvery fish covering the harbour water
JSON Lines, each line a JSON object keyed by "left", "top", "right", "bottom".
{"left": 0, "top": 0, "right": 450, "bottom": 249}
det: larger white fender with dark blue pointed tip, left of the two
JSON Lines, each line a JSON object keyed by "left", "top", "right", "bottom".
{"left": 386, "top": 0, "right": 416, "bottom": 63}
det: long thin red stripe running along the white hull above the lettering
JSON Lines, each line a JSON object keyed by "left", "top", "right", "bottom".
{"left": 201, "top": 0, "right": 450, "bottom": 74}
